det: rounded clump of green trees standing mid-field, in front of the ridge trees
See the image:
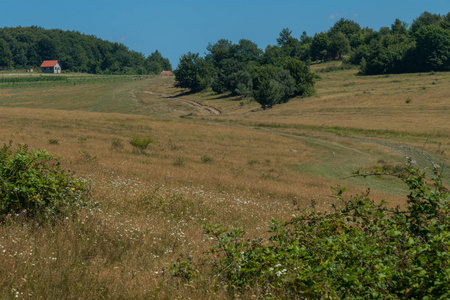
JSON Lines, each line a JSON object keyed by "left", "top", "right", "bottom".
{"left": 174, "top": 39, "right": 314, "bottom": 109}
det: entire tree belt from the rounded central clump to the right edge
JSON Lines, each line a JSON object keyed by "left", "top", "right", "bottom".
{"left": 174, "top": 12, "right": 450, "bottom": 109}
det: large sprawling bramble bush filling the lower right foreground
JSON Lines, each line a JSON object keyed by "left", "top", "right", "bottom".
{"left": 170, "top": 165, "right": 450, "bottom": 299}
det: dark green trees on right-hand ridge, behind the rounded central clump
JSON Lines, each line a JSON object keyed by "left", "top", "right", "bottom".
{"left": 266, "top": 12, "right": 450, "bottom": 75}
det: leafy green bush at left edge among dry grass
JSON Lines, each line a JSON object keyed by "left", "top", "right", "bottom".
{"left": 0, "top": 142, "right": 89, "bottom": 220}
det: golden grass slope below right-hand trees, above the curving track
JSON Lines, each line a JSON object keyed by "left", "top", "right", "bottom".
{"left": 221, "top": 70, "right": 450, "bottom": 139}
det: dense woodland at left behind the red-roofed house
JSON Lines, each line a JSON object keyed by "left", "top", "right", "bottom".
{"left": 0, "top": 26, "right": 172, "bottom": 74}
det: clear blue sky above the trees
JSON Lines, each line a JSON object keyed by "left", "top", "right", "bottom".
{"left": 0, "top": 0, "right": 450, "bottom": 68}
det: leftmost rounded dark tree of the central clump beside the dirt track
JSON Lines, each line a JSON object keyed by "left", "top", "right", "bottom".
{"left": 174, "top": 52, "right": 208, "bottom": 92}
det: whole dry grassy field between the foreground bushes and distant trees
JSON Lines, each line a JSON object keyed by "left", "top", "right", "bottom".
{"left": 0, "top": 64, "right": 450, "bottom": 299}
